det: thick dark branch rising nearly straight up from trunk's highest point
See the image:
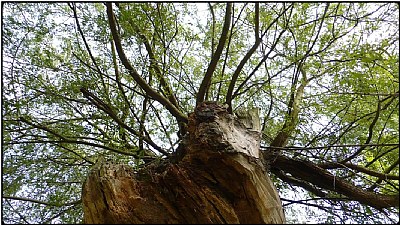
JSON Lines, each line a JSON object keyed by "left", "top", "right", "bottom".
{"left": 196, "top": 3, "right": 232, "bottom": 105}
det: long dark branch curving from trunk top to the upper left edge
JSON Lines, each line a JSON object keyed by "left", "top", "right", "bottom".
{"left": 106, "top": 3, "right": 187, "bottom": 123}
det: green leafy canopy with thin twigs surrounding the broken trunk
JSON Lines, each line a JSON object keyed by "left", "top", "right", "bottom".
{"left": 2, "top": 2, "right": 399, "bottom": 223}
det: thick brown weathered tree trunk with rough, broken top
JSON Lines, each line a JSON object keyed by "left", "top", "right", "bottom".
{"left": 82, "top": 103, "right": 285, "bottom": 223}
